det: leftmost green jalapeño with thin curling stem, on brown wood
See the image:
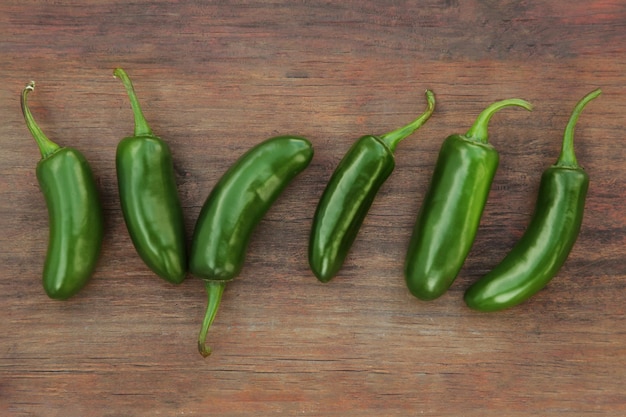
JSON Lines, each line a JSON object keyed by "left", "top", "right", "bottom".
{"left": 21, "top": 81, "right": 104, "bottom": 300}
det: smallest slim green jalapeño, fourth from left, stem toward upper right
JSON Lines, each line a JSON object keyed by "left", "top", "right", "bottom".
{"left": 309, "top": 90, "right": 435, "bottom": 282}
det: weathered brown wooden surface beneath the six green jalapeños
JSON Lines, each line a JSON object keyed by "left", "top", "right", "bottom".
{"left": 0, "top": 0, "right": 626, "bottom": 417}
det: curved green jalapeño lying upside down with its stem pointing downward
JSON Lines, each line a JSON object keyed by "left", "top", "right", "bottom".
{"left": 189, "top": 136, "right": 313, "bottom": 357}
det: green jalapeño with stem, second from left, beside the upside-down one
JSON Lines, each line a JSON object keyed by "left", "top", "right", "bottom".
{"left": 114, "top": 68, "right": 187, "bottom": 284}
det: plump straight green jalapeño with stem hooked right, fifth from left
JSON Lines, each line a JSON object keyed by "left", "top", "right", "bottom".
{"left": 405, "top": 99, "right": 532, "bottom": 300}
